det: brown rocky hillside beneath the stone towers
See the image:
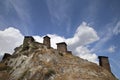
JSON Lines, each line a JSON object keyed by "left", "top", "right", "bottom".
{"left": 0, "top": 36, "right": 116, "bottom": 80}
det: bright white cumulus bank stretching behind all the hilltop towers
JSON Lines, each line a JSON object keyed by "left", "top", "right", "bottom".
{"left": 0, "top": 22, "right": 99, "bottom": 63}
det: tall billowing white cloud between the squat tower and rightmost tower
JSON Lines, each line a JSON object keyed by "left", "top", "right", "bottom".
{"left": 66, "top": 22, "right": 99, "bottom": 63}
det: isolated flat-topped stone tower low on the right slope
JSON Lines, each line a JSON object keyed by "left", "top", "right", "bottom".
{"left": 98, "top": 56, "right": 111, "bottom": 72}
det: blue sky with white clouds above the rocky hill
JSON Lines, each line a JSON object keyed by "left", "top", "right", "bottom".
{"left": 0, "top": 0, "right": 120, "bottom": 78}
